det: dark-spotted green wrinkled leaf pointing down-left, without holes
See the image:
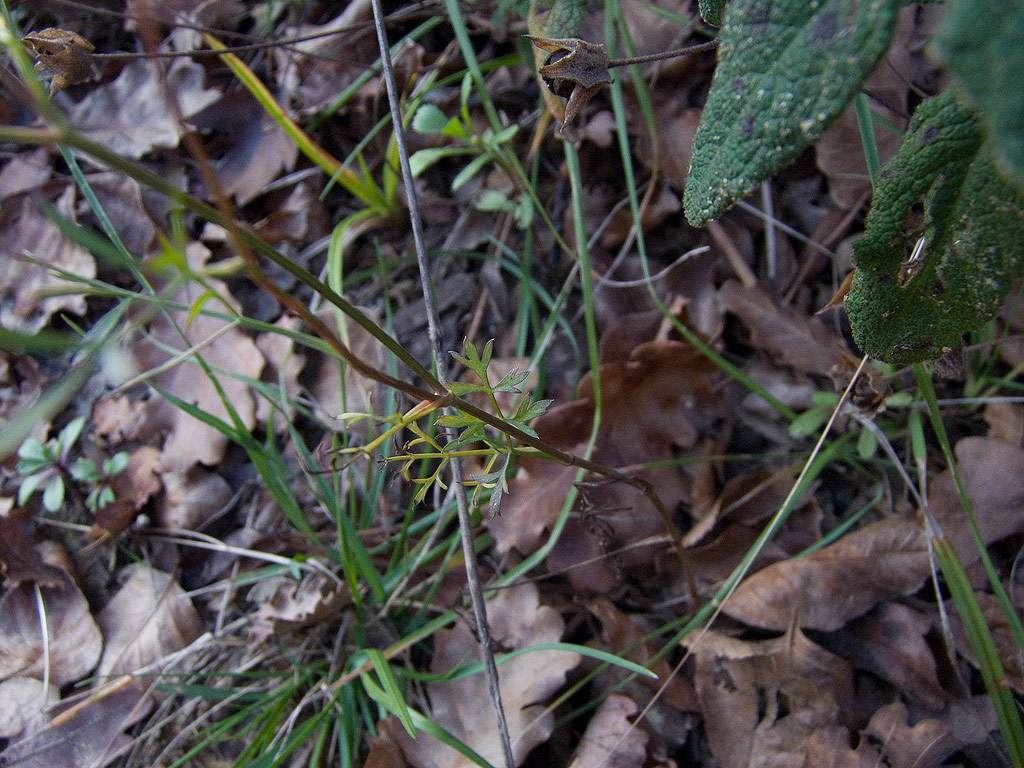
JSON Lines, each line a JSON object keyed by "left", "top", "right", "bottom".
{"left": 683, "top": 0, "right": 901, "bottom": 225}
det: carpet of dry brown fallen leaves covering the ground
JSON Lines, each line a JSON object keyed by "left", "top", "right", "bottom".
{"left": 0, "top": 2, "right": 1024, "bottom": 768}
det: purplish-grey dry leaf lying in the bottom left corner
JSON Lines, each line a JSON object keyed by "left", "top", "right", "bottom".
{"left": 0, "top": 687, "right": 152, "bottom": 768}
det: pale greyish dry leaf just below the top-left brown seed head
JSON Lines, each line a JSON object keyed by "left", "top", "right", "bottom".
{"left": 69, "top": 58, "right": 220, "bottom": 159}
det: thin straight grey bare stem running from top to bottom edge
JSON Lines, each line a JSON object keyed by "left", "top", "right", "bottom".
{"left": 371, "top": 0, "right": 515, "bottom": 768}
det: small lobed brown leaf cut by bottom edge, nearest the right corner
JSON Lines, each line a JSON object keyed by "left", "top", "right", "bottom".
{"left": 864, "top": 702, "right": 963, "bottom": 768}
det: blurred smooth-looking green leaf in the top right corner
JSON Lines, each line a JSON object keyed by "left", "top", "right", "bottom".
{"left": 935, "top": 0, "right": 1024, "bottom": 191}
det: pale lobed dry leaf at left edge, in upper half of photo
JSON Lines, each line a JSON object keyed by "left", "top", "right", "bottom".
{"left": 0, "top": 186, "right": 96, "bottom": 334}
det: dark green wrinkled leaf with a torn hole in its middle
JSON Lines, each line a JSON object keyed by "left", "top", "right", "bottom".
{"left": 846, "top": 91, "right": 1024, "bottom": 364}
